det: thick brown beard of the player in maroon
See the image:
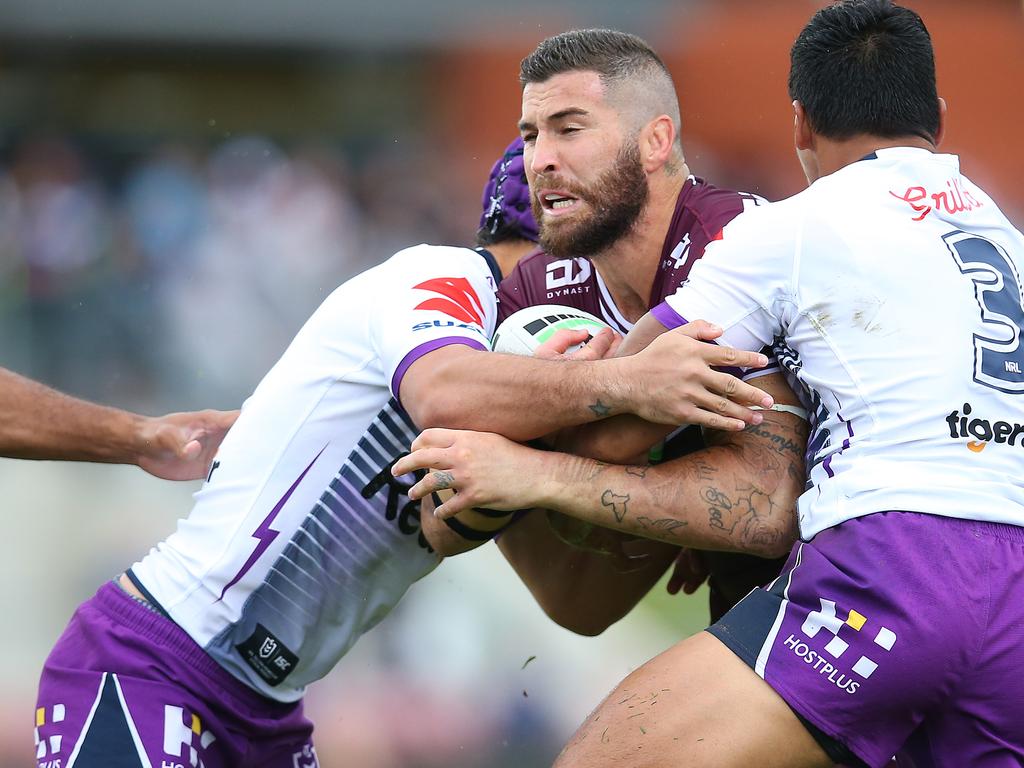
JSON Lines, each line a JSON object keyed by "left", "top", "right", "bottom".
{"left": 530, "top": 141, "right": 650, "bottom": 259}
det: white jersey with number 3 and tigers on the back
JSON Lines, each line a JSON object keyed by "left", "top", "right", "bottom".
{"left": 654, "top": 147, "right": 1024, "bottom": 539}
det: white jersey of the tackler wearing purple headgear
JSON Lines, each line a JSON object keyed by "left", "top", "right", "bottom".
{"left": 131, "top": 246, "right": 500, "bottom": 701}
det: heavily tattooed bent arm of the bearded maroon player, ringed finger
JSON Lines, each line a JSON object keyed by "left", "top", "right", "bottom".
{"left": 396, "top": 377, "right": 807, "bottom": 557}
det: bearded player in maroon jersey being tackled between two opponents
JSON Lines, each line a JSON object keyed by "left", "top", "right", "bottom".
{"left": 398, "top": 30, "right": 807, "bottom": 634}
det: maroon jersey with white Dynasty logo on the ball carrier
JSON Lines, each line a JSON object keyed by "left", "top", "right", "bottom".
{"left": 498, "top": 176, "right": 765, "bottom": 333}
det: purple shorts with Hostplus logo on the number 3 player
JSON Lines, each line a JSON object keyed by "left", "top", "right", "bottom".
{"left": 708, "top": 512, "right": 1024, "bottom": 768}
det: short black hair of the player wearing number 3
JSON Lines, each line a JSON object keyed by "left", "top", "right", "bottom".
{"left": 790, "top": 0, "right": 939, "bottom": 142}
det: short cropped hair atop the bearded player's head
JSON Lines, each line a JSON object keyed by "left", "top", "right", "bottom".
{"left": 519, "top": 30, "right": 669, "bottom": 86}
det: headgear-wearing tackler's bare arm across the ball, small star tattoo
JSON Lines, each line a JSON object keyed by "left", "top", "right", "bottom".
{"left": 400, "top": 322, "right": 771, "bottom": 440}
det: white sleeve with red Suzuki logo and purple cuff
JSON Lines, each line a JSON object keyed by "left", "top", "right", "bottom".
{"left": 371, "top": 246, "right": 498, "bottom": 397}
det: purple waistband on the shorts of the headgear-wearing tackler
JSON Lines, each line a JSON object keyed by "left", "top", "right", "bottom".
{"left": 92, "top": 582, "right": 295, "bottom": 711}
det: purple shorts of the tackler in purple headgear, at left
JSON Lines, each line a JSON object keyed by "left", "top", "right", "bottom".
{"left": 35, "top": 583, "right": 317, "bottom": 768}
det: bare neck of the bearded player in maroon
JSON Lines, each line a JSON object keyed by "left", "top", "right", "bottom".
{"left": 591, "top": 163, "right": 690, "bottom": 323}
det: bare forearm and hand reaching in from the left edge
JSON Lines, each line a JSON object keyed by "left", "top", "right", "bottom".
{"left": 0, "top": 369, "right": 238, "bottom": 480}
